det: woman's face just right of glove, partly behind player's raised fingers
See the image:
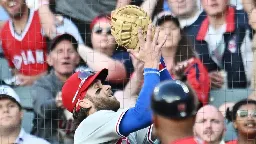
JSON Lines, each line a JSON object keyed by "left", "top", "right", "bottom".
{"left": 158, "top": 21, "right": 181, "bottom": 48}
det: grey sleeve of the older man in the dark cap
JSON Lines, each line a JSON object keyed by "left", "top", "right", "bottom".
{"left": 31, "top": 81, "right": 58, "bottom": 118}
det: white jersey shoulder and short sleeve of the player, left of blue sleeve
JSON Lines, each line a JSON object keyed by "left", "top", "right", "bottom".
{"left": 74, "top": 110, "right": 127, "bottom": 144}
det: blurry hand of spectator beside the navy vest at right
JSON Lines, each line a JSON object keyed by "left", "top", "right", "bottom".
{"left": 209, "top": 71, "right": 224, "bottom": 89}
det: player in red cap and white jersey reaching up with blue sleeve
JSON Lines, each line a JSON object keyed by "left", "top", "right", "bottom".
{"left": 62, "top": 25, "right": 169, "bottom": 144}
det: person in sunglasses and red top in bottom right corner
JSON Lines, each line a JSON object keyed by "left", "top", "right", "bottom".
{"left": 227, "top": 99, "right": 256, "bottom": 144}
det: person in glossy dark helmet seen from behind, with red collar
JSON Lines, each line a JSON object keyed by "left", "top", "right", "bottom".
{"left": 151, "top": 80, "right": 199, "bottom": 144}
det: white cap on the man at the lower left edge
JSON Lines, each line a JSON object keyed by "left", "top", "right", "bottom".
{"left": 0, "top": 85, "right": 21, "bottom": 106}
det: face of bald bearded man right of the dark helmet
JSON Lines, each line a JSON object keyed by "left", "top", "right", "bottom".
{"left": 194, "top": 106, "right": 224, "bottom": 143}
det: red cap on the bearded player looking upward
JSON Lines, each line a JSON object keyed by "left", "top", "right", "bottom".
{"left": 62, "top": 69, "right": 108, "bottom": 112}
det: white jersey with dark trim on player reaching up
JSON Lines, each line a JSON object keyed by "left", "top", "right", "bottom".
{"left": 74, "top": 110, "right": 152, "bottom": 144}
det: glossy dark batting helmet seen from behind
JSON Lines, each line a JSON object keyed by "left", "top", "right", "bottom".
{"left": 151, "top": 80, "right": 197, "bottom": 119}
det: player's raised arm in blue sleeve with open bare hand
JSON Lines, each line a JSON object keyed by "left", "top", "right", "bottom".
{"left": 119, "top": 25, "right": 166, "bottom": 136}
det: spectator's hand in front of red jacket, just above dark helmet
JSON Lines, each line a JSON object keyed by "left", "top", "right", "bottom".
{"left": 172, "top": 58, "right": 194, "bottom": 79}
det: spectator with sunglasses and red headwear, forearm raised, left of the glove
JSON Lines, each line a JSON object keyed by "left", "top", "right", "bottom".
{"left": 78, "top": 14, "right": 134, "bottom": 91}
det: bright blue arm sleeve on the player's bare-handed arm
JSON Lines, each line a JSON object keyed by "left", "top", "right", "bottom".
{"left": 119, "top": 69, "right": 160, "bottom": 136}
